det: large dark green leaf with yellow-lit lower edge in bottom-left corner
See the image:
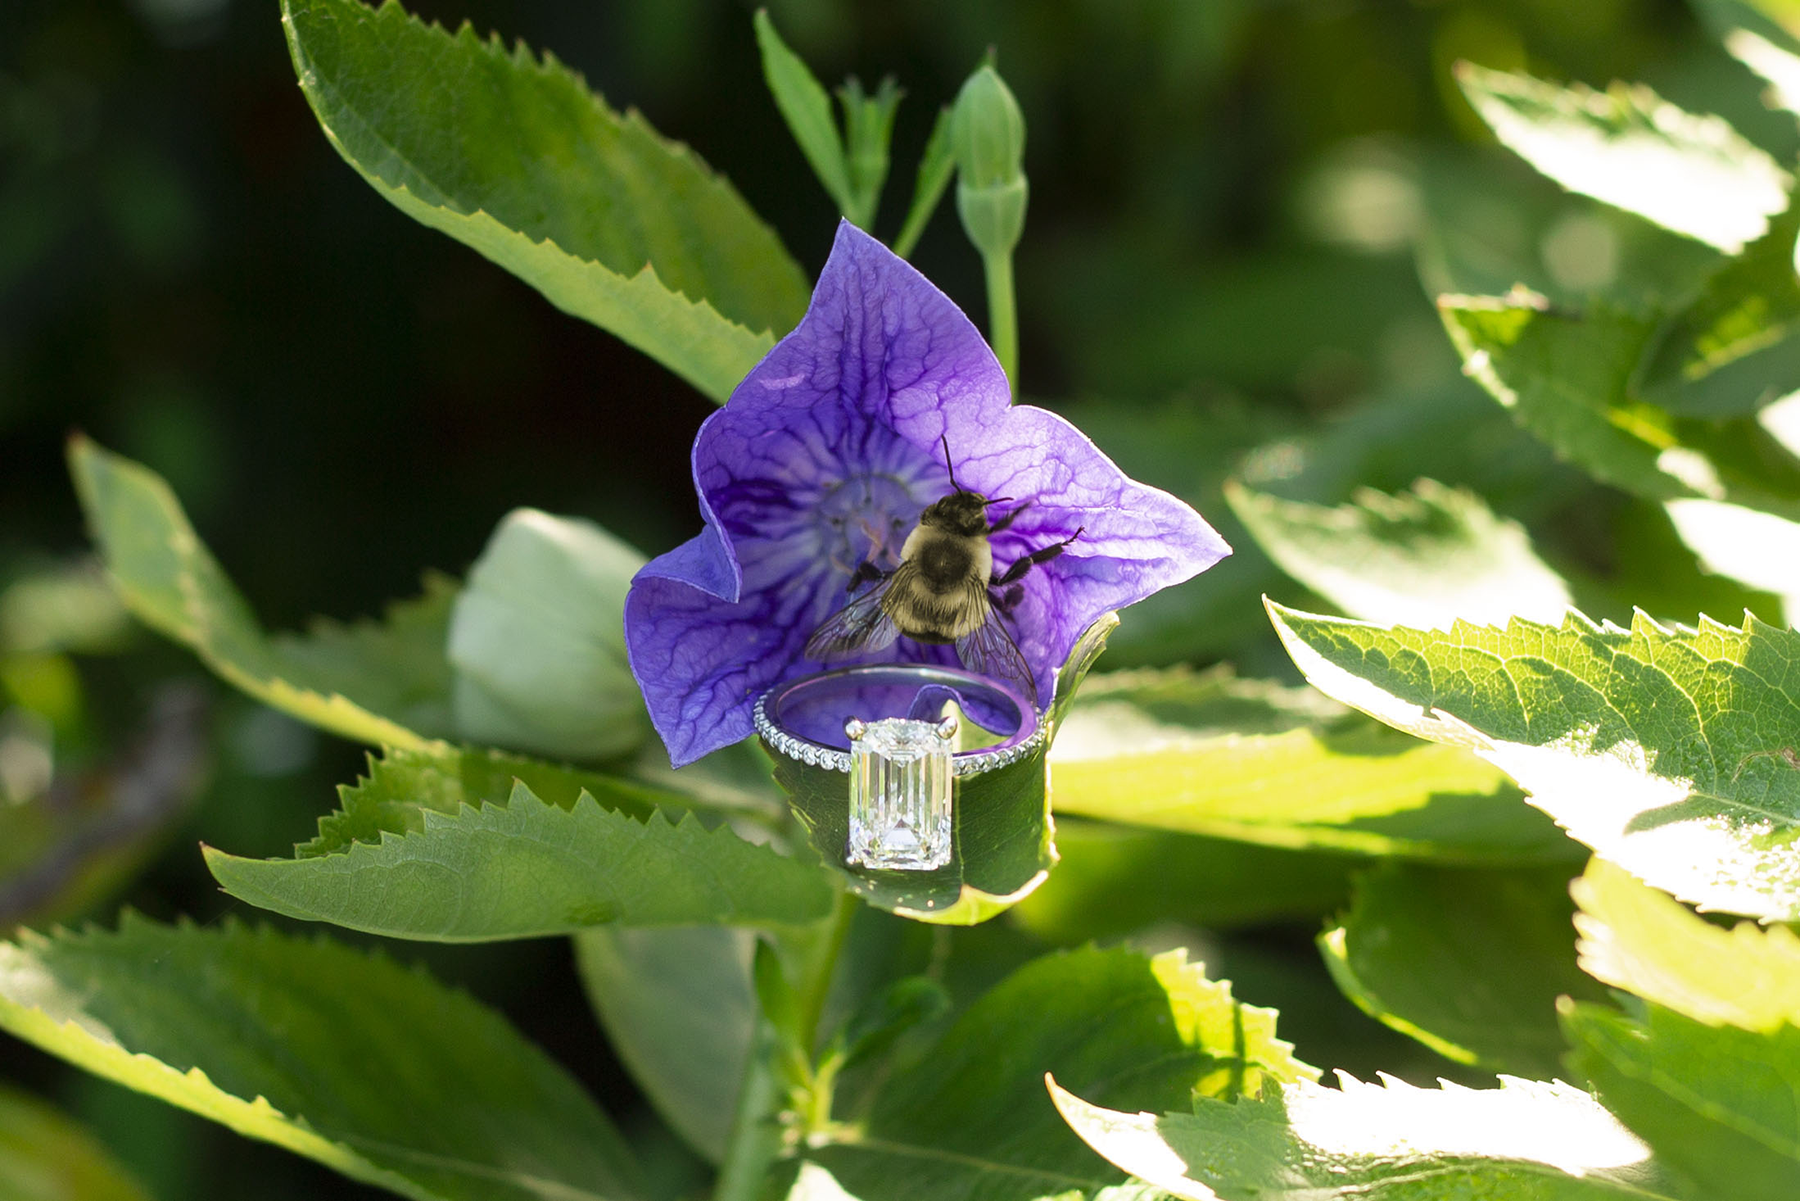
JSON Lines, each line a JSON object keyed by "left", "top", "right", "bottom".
{"left": 0, "top": 915, "right": 643, "bottom": 1201}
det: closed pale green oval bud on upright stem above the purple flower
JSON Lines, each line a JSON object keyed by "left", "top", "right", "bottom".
{"left": 954, "top": 67, "right": 1030, "bottom": 256}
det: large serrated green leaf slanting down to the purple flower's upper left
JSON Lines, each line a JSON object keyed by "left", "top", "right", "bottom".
{"left": 283, "top": 0, "right": 806, "bottom": 400}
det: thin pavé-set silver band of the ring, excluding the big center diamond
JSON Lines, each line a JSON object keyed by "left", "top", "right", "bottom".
{"left": 752, "top": 663, "right": 1044, "bottom": 776}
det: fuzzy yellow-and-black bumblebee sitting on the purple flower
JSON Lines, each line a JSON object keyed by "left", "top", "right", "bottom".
{"left": 805, "top": 443, "right": 1082, "bottom": 704}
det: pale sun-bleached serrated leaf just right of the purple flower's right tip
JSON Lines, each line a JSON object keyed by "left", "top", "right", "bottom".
{"left": 1226, "top": 479, "right": 1570, "bottom": 627}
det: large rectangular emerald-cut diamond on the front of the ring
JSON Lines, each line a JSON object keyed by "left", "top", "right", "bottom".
{"left": 844, "top": 717, "right": 956, "bottom": 871}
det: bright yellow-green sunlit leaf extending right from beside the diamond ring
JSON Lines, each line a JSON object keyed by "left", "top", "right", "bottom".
{"left": 1051, "top": 668, "right": 1577, "bottom": 862}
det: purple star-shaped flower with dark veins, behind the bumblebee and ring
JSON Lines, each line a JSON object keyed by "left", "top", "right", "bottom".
{"left": 625, "top": 221, "right": 1229, "bottom": 765}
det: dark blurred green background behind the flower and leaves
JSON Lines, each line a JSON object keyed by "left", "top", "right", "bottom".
{"left": 0, "top": 0, "right": 1771, "bottom": 1199}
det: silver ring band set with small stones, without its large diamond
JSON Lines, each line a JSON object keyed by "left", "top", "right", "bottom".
{"left": 752, "top": 663, "right": 1044, "bottom": 776}
